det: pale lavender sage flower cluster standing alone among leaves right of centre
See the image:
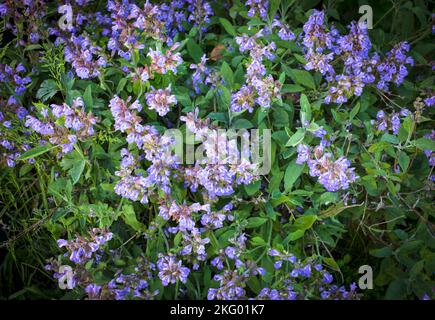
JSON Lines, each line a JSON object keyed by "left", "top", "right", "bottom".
{"left": 296, "top": 144, "right": 358, "bottom": 192}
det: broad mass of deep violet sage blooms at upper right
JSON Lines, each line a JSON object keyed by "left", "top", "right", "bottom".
{"left": 301, "top": 10, "right": 413, "bottom": 103}
